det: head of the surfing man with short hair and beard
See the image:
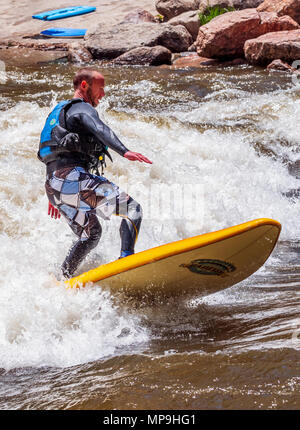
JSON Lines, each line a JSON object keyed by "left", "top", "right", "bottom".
{"left": 73, "top": 69, "right": 105, "bottom": 107}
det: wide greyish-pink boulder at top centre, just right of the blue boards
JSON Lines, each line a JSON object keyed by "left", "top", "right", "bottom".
{"left": 85, "top": 22, "right": 193, "bottom": 60}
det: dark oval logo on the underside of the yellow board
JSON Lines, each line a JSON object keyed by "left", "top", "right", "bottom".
{"left": 180, "top": 259, "right": 236, "bottom": 277}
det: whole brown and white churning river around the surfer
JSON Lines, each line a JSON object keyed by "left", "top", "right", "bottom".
{"left": 0, "top": 63, "right": 300, "bottom": 409}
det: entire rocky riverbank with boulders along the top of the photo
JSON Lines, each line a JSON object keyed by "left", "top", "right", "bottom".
{"left": 0, "top": 0, "right": 300, "bottom": 73}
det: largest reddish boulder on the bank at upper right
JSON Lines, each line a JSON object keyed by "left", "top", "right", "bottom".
{"left": 196, "top": 9, "right": 299, "bottom": 59}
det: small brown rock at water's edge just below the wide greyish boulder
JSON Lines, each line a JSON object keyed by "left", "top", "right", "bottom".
{"left": 111, "top": 46, "right": 172, "bottom": 66}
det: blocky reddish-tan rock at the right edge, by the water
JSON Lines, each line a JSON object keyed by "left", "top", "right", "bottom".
{"left": 244, "top": 30, "right": 300, "bottom": 65}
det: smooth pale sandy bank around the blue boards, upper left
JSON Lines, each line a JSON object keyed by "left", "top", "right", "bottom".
{"left": 0, "top": 0, "right": 157, "bottom": 66}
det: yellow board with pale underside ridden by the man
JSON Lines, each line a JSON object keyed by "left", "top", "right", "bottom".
{"left": 65, "top": 218, "right": 281, "bottom": 295}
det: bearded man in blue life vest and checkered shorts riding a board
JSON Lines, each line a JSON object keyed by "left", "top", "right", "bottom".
{"left": 38, "top": 69, "right": 152, "bottom": 278}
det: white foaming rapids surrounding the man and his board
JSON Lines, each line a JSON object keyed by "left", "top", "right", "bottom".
{"left": 0, "top": 72, "right": 300, "bottom": 369}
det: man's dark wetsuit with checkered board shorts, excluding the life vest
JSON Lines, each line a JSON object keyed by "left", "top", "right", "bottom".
{"left": 45, "top": 98, "right": 142, "bottom": 277}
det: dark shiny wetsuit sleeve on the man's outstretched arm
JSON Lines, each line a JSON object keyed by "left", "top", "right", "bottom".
{"left": 68, "top": 103, "right": 128, "bottom": 156}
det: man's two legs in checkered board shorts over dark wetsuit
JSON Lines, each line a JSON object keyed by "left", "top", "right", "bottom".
{"left": 46, "top": 168, "right": 142, "bottom": 277}
